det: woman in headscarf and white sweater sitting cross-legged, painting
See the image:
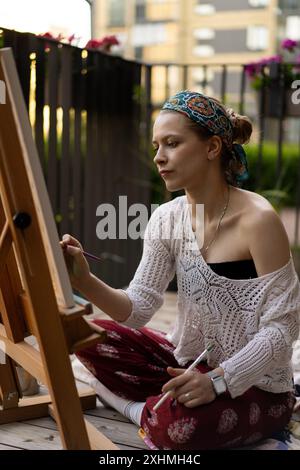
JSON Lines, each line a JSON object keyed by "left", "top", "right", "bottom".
{"left": 62, "top": 91, "right": 300, "bottom": 450}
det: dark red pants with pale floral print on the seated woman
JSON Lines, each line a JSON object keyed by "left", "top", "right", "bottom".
{"left": 77, "top": 320, "right": 295, "bottom": 450}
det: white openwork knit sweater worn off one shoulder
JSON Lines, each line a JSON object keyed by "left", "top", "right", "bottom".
{"left": 120, "top": 196, "right": 300, "bottom": 398}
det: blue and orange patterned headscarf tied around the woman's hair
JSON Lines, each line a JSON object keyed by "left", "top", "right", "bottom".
{"left": 162, "top": 90, "right": 249, "bottom": 182}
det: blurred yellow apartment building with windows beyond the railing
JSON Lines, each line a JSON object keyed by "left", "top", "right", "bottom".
{"left": 92, "top": 0, "right": 300, "bottom": 100}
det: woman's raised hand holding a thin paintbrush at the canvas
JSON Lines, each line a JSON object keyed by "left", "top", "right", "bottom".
{"left": 60, "top": 234, "right": 90, "bottom": 290}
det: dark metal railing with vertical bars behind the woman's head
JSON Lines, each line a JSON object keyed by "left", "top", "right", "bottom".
{"left": 142, "top": 63, "right": 300, "bottom": 245}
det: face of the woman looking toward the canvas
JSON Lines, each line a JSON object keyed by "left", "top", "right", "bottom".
{"left": 153, "top": 112, "right": 209, "bottom": 191}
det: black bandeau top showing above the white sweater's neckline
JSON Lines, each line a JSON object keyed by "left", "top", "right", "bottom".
{"left": 206, "top": 259, "right": 257, "bottom": 279}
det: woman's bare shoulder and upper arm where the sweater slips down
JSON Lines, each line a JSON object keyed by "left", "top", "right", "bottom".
{"left": 232, "top": 186, "right": 290, "bottom": 276}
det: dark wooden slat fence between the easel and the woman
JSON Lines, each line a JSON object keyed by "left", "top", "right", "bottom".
{"left": 0, "top": 29, "right": 151, "bottom": 287}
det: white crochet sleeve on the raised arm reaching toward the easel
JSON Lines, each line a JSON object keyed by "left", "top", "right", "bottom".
{"left": 122, "top": 205, "right": 175, "bottom": 328}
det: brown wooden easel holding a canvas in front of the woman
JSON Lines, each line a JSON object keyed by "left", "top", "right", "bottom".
{"left": 0, "top": 49, "right": 117, "bottom": 450}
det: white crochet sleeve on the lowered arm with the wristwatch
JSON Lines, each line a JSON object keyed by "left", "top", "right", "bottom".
{"left": 220, "top": 263, "right": 300, "bottom": 398}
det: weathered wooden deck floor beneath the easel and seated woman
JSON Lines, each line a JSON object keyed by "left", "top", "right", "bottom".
{"left": 0, "top": 292, "right": 176, "bottom": 450}
